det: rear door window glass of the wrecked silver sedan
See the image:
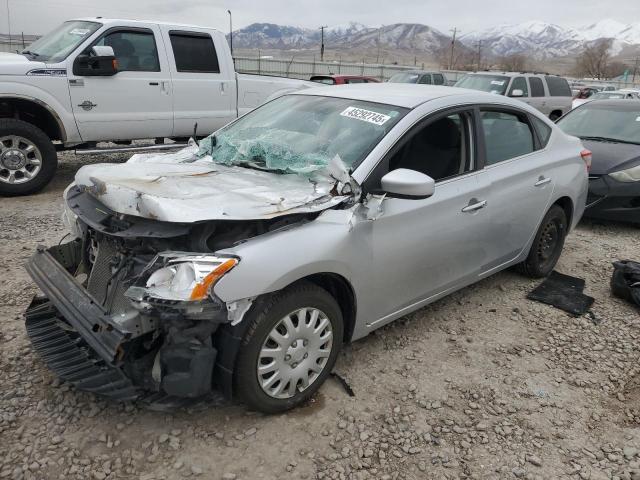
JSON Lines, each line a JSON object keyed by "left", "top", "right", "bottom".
{"left": 480, "top": 109, "right": 534, "bottom": 165}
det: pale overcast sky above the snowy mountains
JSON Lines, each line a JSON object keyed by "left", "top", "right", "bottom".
{"left": 0, "top": 0, "right": 640, "bottom": 34}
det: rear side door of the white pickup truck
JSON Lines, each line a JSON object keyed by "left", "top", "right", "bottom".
{"left": 160, "top": 25, "right": 237, "bottom": 137}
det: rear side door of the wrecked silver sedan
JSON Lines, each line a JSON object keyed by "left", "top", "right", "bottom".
{"left": 479, "top": 106, "right": 555, "bottom": 273}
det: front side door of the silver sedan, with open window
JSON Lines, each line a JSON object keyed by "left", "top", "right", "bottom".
{"left": 367, "top": 108, "right": 489, "bottom": 328}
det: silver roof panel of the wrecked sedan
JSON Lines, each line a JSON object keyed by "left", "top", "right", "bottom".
{"left": 292, "top": 82, "right": 523, "bottom": 108}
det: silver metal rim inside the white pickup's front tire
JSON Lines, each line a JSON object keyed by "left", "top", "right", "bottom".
{"left": 0, "top": 135, "right": 42, "bottom": 183}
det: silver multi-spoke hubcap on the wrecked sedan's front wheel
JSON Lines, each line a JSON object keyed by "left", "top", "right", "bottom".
{"left": 257, "top": 308, "right": 333, "bottom": 398}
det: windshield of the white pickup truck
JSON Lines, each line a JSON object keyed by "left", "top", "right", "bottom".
{"left": 22, "top": 20, "right": 102, "bottom": 63}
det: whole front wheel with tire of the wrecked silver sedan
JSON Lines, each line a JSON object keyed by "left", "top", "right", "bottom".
{"left": 235, "top": 282, "right": 343, "bottom": 413}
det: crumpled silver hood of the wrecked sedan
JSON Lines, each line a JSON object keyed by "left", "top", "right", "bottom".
{"left": 75, "top": 147, "right": 350, "bottom": 223}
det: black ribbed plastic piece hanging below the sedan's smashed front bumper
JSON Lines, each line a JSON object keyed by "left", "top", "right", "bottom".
{"left": 25, "top": 298, "right": 141, "bottom": 401}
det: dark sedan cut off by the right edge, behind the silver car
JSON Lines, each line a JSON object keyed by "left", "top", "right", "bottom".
{"left": 558, "top": 100, "right": 640, "bottom": 224}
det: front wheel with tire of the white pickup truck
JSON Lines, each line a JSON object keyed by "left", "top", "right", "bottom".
{"left": 0, "top": 119, "right": 58, "bottom": 196}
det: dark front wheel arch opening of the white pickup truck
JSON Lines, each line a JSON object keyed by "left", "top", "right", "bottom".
{"left": 0, "top": 95, "right": 67, "bottom": 142}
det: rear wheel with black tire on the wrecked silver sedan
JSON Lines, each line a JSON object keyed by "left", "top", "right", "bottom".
{"left": 518, "top": 205, "right": 567, "bottom": 278}
